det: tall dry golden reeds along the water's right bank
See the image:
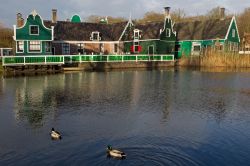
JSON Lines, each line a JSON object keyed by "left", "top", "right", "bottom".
{"left": 178, "top": 53, "right": 250, "bottom": 68}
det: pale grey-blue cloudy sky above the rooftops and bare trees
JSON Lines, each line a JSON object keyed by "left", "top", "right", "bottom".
{"left": 0, "top": 0, "right": 250, "bottom": 27}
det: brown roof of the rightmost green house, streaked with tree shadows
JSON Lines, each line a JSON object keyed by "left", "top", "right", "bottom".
{"left": 174, "top": 18, "right": 232, "bottom": 40}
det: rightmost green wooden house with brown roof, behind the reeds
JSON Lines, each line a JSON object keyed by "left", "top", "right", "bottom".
{"left": 174, "top": 17, "right": 240, "bottom": 58}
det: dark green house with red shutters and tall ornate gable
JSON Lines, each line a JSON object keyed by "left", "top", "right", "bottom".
{"left": 122, "top": 7, "right": 176, "bottom": 55}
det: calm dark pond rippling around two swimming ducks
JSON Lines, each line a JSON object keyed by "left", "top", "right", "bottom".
{"left": 0, "top": 69, "right": 250, "bottom": 166}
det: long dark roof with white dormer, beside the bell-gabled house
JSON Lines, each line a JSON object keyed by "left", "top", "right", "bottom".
{"left": 44, "top": 21, "right": 127, "bottom": 41}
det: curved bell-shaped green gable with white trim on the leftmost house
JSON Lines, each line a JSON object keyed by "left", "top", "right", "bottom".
{"left": 14, "top": 13, "right": 53, "bottom": 40}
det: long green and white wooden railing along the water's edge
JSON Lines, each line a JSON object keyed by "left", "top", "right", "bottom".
{"left": 2, "top": 55, "right": 174, "bottom": 66}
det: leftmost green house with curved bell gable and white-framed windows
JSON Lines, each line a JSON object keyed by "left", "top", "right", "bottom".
{"left": 13, "top": 11, "right": 54, "bottom": 56}
